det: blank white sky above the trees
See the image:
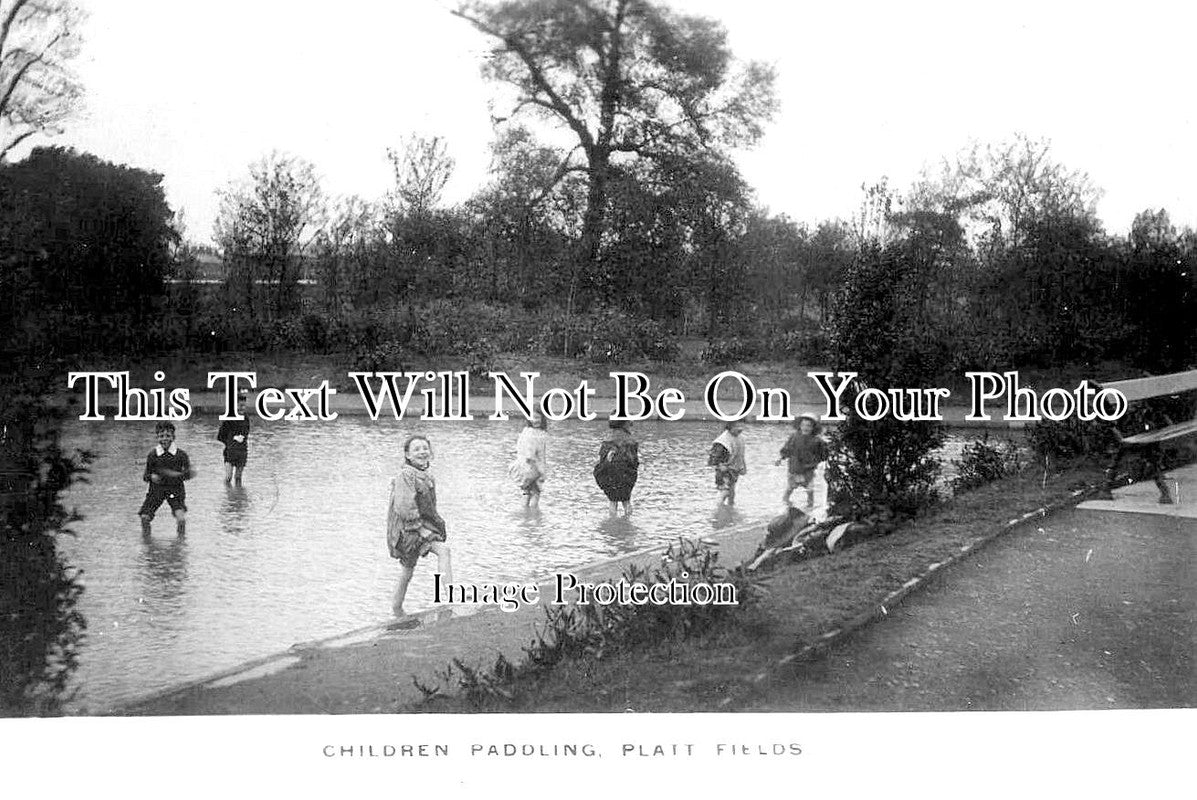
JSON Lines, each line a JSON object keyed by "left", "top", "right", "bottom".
{"left": 18, "top": 0, "right": 1197, "bottom": 242}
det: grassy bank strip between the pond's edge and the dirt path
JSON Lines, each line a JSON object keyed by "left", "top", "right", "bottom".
{"left": 405, "top": 465, "right": 1100, "bottom": 713}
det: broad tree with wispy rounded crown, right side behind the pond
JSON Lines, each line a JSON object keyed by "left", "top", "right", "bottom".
{"left": 897, "top": 134, "right": 1114, "bottom": 369}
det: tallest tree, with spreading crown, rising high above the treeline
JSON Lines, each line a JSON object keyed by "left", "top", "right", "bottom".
{"left": 454, "top": 0, "right": 774, "bottom": 291}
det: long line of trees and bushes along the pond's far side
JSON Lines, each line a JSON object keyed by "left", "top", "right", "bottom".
{"left": 0, "top": 139, "right": 1197, "bottom": 370}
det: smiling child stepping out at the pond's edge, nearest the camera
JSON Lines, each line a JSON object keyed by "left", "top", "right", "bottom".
{"left": 387, "top": 435, "right": 452, "bottom": 618}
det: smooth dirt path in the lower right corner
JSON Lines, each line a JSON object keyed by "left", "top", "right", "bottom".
{"left": 737, "top": 510, "right": 1197, "bottom": 711}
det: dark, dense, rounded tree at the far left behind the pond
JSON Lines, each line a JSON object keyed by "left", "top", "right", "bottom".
{"left": 0, "top": 147, "right": 178, "bottom": 351}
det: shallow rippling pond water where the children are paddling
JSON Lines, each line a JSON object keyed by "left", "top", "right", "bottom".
{"left": 53, "top": 417, "right": 1010, "bottom": 710}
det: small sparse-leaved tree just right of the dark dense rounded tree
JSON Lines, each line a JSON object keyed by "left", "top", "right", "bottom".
{"left": 215, "top": 152, "right": 324, "bottom": 319}
